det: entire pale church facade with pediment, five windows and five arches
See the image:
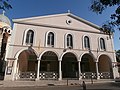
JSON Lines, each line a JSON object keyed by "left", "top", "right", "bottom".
{"left": 4, "top": 13, "right": 118, "bottom": 80}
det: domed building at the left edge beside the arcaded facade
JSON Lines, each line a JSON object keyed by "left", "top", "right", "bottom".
{"left": 0, "top": 11, "right": 12, "bottom": 80}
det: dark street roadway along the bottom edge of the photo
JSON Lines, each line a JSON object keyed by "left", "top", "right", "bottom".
{"left": 0, "top": 82, "right": 120, "bottom": 90}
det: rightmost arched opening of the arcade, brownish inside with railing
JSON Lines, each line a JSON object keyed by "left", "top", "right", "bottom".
{"left": 98, "top": 55, "right": 113, "bottom": 79}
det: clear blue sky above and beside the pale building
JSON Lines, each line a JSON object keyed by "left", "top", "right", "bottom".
{"left": 0, "top": 0, "right": 120, "bottom": 50}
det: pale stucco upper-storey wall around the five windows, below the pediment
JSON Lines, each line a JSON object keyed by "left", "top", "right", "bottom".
{"left": 8, "top": 21, "right": 114, "bottom": 57}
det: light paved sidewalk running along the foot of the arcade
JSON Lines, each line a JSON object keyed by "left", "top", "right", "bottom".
{"left": 0, "top": 80, "right": 114, "bottom": 87}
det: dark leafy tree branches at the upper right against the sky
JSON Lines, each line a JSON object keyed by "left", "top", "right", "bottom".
{"left": 90, "top": 0, "right": 120, "bottom": 32}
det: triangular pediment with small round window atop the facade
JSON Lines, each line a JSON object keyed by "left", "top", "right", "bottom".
{"left": 13, "top": 13, "right": 100, "bottom": 32}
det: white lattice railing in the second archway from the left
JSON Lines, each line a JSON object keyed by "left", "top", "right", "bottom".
{"left": 39, "top": 72, "right": 58, "bottom": 80}
